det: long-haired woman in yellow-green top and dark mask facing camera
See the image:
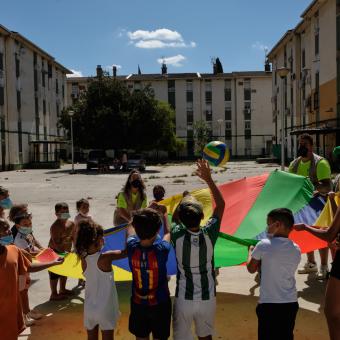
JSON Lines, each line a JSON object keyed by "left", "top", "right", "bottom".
{"left": 113, "top": 169, "right": 147, "bottom": 226}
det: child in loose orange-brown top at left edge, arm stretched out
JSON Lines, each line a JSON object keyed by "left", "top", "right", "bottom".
{"left": 0, "top": 219, "right": 63, "bottom": 340}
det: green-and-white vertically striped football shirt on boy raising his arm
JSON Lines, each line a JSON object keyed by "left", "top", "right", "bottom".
{"left": 171, "top": 216, "right": 220, "bottom": 300}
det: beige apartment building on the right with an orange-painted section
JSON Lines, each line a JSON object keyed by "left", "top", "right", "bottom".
{"left": 268, "top": 0, "right": 340, "bottom": 159}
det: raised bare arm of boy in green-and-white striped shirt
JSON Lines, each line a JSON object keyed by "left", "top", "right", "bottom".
{"left": 196, "top": 159, "right": 225, "bottom": 221}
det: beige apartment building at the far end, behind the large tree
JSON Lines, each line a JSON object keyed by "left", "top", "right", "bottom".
{"left": 67, "top": 64, "right": 273, "bottom": 157}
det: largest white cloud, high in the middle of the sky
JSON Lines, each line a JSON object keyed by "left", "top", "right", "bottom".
{"left": 127, "top": 28, "right": 196, "bottom": 49}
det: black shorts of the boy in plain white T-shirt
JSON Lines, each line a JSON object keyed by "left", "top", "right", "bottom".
{"left": 256, "top": 302, "right": 299, "bottom": 340}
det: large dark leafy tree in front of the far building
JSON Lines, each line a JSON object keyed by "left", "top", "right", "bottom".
{"left": 59, "top": 75, "right": 176, "bottom": 151}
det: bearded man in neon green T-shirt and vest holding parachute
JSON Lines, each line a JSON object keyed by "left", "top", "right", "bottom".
{"left": 289, "top": 133, "right": 332, "bottom": 280}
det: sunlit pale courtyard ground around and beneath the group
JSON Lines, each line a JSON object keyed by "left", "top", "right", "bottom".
{"left": 0, "top": 161, "right": 328, "bottom": 340}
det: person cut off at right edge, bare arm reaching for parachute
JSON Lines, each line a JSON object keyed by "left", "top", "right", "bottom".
{"left": 294, "top": 202, "right": 340, "bottom": 340}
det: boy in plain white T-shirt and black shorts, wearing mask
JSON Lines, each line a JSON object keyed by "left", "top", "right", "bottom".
{"left": 247, "top": 208, "right": 301, "bottom": 340}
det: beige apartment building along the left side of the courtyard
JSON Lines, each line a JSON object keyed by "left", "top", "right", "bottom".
{"left": 0, "top": 25, "right": 72, "bottom": 170}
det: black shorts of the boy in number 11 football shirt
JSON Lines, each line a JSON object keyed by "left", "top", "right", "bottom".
{"left": 129, "top": 298, "right": 171, "bottom": 340}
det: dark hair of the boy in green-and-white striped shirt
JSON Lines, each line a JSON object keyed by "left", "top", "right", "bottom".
{"left": 178, "top": 195, "right": 203, "bottom": 229}
